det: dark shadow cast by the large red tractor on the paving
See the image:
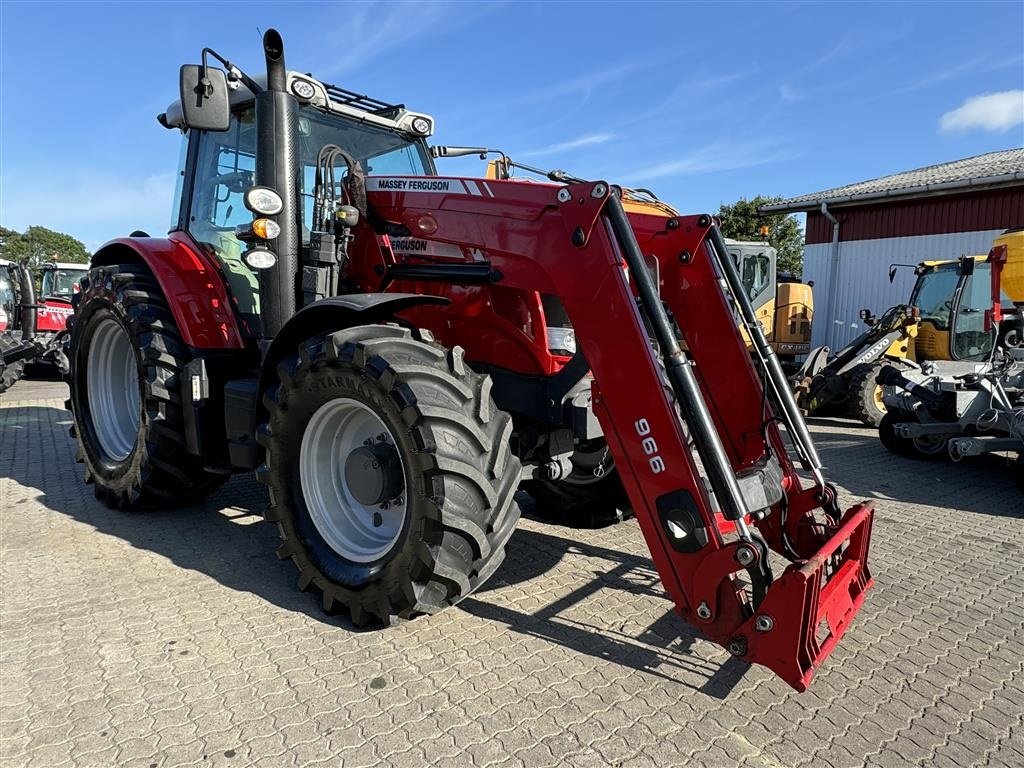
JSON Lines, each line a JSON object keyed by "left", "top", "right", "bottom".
{"left": 0, "top": 406, "right": 748, "bottom": 697}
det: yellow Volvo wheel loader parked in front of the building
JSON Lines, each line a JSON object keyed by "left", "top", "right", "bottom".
{"left": 794, "top": 249, "right": 992, "bottom": 427}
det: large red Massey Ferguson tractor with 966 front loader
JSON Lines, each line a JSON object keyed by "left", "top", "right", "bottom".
{"left": 70, "top": 30, "right": 873, "bottom": 689}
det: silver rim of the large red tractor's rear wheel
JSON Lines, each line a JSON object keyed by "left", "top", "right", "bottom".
{"left": 86, "top": 318, "right": 141, "bottom": 461}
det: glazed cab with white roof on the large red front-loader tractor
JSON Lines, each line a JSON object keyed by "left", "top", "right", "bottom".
{"left": 158, "top": 72, "right": 435, "bottom": 337}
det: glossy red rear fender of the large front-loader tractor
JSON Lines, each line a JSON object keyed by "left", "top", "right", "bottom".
{"left": 91, "top": 232, "right": 246, "bottom": 349}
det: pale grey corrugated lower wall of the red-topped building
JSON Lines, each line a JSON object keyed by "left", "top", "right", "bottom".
{"left": 804, "top": 228, "right": 1002, "bottom": 350}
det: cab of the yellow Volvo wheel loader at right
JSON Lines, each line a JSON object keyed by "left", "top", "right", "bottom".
{"left": 910, "top": 255, "right": 1011, "bottom": 361}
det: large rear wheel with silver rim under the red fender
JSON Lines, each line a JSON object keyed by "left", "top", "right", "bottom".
{"left": 68, "top": 265, "right": 226, "bottom": 509}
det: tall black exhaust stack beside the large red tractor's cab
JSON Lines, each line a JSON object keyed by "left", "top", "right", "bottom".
{"left": 256, "top": 30, "right": 302, "bottom": 339}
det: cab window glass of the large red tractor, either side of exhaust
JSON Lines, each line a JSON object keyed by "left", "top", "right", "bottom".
{"left": 188, "top": 104, "right": 432, "bottom": 323}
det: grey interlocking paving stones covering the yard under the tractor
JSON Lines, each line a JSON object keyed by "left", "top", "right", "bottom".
{"left": 0, "top": 383, "right": 1024, "bottom": 768}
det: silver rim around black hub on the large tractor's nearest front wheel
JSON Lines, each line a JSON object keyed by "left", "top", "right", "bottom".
{"left": 299, "top": 397, "right": 408, "bottom": 563}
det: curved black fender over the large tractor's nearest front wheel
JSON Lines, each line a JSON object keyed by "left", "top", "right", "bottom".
{"left": 259, "top": 293, "right": 450, "bottom": 392}
